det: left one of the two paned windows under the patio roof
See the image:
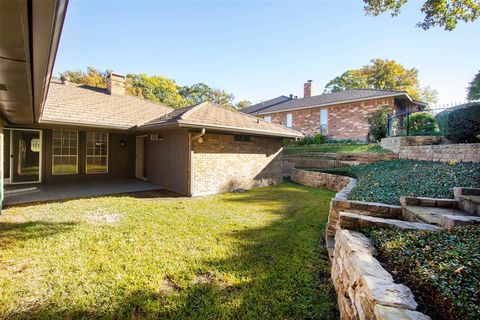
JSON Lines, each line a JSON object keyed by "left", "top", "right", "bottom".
{"left": 52, "top": 130, "right": 78, "bottom": 175}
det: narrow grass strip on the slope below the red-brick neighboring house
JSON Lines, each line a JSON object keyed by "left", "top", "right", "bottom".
{"left": 283, "top": 143, "right": 390, "bottom": 155}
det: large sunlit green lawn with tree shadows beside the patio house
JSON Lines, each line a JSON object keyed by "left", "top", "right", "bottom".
{"left": 0, "top": 183, "right": 336, "bottom": 319}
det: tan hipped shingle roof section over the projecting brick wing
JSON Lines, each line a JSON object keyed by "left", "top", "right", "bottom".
{"left": 139, "top": 102, "right": 303, "bottom": 138}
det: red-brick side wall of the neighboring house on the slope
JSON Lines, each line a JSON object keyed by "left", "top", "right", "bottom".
{"left": 258, "top": 98, "right": 395, "bottom": 140}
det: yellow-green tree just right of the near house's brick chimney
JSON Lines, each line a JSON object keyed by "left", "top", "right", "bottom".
{"left": 126, "top": 73, "right": 187, "bottom": 108}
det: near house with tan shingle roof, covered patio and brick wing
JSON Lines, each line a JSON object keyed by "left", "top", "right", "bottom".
{"left": 4, "top": 73, "right": 302, "bottom": 196}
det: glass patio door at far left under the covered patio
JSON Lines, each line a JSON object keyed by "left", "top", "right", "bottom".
{"left": 4, "top": 129, "right": 42, "bottom": 183}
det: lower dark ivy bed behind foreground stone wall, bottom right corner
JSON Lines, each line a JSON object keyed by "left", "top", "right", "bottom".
{"left": 366, "top": 226, "right": 480, "bottom": 320}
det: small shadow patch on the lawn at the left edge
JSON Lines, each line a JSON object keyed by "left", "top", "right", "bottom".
{"left": 0, "top": 221, "right": 76, "bottom": 248}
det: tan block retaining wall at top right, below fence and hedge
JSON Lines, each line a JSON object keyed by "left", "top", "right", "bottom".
{"left": 380, "top": 136, "right": 480, "bottom": 163}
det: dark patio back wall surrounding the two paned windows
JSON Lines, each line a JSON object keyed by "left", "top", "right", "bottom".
{"left": 42, "top": 128, "right": 135, "bottom": 183}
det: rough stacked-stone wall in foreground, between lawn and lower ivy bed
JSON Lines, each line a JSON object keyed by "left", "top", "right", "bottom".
{"left": 332, "top": 230, "right": 430, "bottom": 320}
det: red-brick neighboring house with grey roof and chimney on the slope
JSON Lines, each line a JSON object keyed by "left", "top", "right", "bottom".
{"left": 241, "top": 80, "right": 428, "bottom": 140}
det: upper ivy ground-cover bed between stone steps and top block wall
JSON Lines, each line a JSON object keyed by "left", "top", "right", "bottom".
{"left": 312, "top": 160, "right": 480, "bottom": 204}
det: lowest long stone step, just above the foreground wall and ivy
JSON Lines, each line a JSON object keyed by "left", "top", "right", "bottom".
{"left": 339, "top": 211, "right": 438, "bottom": 230}
